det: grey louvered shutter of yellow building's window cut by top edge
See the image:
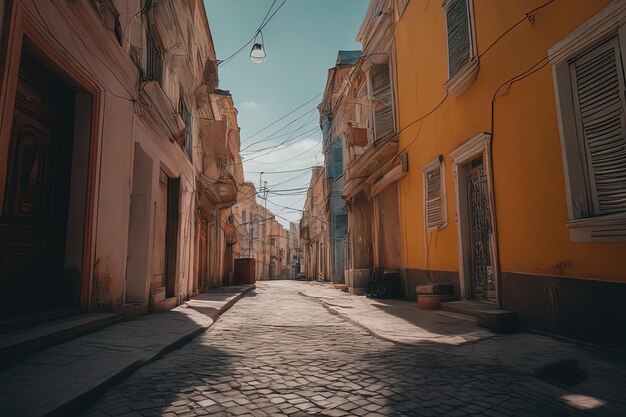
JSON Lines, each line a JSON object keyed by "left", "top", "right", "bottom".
{"left": 446, "top": 0, "right": 471, "bottom": 78}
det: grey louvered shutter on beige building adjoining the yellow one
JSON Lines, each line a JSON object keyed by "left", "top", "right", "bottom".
{"left": 371, "top": 64, "right": 394, "bottom": 140}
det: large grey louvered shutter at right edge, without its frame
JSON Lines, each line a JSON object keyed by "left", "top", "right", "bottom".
{"left": 570, "top": 38, "right": 626, "bottom": 215}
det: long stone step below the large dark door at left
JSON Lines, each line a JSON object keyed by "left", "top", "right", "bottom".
{"left": 0, "top": 313, "right": 120, "bottom": 363}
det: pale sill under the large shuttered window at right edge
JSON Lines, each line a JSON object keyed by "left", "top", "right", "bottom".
{"left": 567, "top": 213, "right": 626, "bottom": 242}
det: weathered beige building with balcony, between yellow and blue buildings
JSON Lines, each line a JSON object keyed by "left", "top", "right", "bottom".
{"left": 342, "top": 0, "right": 408, "bottom": 293}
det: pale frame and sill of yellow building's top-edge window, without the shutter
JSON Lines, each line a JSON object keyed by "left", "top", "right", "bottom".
{"left": 441, "top": 0, "right": 479, "bottom": 97}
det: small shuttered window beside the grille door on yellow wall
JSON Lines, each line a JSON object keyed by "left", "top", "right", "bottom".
{"left": 422, "top": 156, "right": 447, "bottom": 231}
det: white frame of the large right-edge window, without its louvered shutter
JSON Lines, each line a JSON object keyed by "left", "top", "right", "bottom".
{"left": 548, "top": 1, "right": 626, "bottom": 242}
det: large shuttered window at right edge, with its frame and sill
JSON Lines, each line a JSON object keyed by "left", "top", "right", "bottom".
{"left": 549, "top": 4, "right": 626, "bottom": 242}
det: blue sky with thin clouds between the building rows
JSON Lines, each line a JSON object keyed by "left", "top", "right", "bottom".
{"left": 205, "top": 0, "right": 369, "bottom": 224}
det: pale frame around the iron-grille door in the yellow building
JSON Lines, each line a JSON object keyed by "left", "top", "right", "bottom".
{"left": 449, "top": 132, "right": 502, "bottom": 304}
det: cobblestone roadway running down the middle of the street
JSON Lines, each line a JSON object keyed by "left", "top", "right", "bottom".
{"left": 84, "top": 281, "right": 626, "bottom": 417}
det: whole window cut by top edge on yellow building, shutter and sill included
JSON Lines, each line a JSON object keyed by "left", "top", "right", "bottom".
{"left": 443, "top": 0, "right": 478, "bottom": 97}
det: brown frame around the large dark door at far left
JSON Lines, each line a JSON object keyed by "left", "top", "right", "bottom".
{"left": 0, "top": 0, "right": 104, "bottom": 310}
